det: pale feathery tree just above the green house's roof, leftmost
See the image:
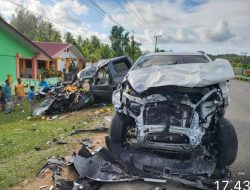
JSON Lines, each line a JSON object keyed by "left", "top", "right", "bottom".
{"left": 10, "top": 8, "right": 38, "bottom": 40}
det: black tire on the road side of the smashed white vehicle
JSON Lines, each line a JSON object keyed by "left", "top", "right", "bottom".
{"left": 217, "top": 118, "right": 238, "bottom": 168}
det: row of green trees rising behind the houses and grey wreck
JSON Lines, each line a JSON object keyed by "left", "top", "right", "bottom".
{"left": 11, "top": 9, "right": 142, "bottom": 62}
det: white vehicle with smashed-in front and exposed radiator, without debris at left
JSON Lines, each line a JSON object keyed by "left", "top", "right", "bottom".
{"left": 109, "top": 52, "right": 238, "bottom": 187}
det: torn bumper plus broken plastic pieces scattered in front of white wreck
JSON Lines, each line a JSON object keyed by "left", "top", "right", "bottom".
{"left": 38, "top": 137, "right": 230, "bottom": 190}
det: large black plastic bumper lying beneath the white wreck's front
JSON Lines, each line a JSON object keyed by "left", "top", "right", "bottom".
{"left": 73, "top": 137, "right": 231, "bottom": 189}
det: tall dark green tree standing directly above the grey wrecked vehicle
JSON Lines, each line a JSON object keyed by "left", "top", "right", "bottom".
{"left": 109, "top": 25, "right": 129, "bottom": 56}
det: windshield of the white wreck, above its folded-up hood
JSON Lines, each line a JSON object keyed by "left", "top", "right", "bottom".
{"left": 132, "top": 55, "right": 209, "bottom": 70}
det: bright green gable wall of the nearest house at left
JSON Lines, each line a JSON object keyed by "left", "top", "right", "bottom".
{"left": 0, "top": 28, "right": 35, "bottom": 84}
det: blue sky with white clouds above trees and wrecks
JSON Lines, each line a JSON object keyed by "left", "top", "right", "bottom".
{"left": 0, "top": 0, "right": 250, "bottom": 55}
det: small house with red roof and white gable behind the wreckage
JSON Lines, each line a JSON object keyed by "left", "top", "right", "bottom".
{"left": 33, "top": 42, "right": 85, "bottom": 78}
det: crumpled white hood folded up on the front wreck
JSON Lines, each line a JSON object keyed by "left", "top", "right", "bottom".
{"left": 127, "top": 59, "right": 234, "bottom": 93}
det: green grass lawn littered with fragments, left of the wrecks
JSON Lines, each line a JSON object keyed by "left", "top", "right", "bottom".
{"left": 0, "top": 102, "right": 111, "bottom": 189}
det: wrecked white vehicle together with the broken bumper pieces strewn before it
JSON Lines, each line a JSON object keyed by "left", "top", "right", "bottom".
{"left": 39, "top": 52, "right": 238, "bottom": 190}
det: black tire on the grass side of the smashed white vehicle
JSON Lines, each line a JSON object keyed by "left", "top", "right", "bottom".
{"left": 109, "top": 112, "right": 128, "bottom": 145}
